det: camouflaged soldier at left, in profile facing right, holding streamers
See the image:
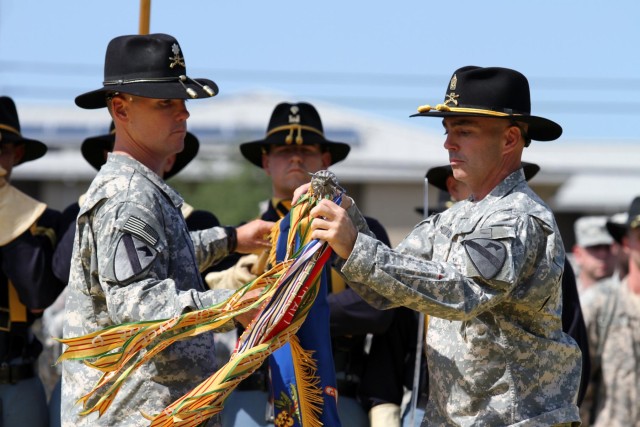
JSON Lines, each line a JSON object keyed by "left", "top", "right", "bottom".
{"left": 62, "top": 34, "right": 272, "bottom": 427}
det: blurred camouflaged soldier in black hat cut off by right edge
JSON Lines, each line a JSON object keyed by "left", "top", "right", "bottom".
{"left": 581, "top": 197, "right": 640, "bottom": 427}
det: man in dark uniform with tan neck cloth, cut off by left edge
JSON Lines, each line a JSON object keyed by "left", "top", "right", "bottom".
{"left": 0, "top": 96, "right": 64, "bottom": 427}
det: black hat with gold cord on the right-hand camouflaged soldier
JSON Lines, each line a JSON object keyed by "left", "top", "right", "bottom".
{"left": 411, "top": 66, "right": 562, "bottom": 141}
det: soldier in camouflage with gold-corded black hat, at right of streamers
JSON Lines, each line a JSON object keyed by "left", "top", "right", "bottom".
{"left": 304, "top": 67, "right": 581, "bottom": 426}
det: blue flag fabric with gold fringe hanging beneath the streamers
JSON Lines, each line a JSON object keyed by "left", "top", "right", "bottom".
{"left": 269, "top": 214, "right": 341, "bottom": 427}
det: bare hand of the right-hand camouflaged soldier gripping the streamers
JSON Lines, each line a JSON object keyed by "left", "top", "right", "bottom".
{"left": 311, "top": 199, "right": 358, "bottom": 259}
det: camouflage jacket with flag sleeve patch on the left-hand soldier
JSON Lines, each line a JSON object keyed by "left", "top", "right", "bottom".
{"left": 62, "top": 154, "right": 233, "bottom": 426}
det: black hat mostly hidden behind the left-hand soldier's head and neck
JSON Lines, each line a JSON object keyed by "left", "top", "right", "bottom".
{"left": 80, "top": 122, "right": 200, "bottom": 179}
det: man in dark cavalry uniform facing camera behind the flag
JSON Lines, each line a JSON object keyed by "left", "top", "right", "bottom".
{"left": 223, "top": 102, "right": 402, "bottom": 427}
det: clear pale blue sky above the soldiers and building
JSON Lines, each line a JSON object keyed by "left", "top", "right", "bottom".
{"left": 0, "top": 0, "right": 640, "bottom": 142}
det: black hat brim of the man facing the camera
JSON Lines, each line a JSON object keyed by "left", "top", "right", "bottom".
{"left": 240, "top": 131, "right": 351, "bottom": 168}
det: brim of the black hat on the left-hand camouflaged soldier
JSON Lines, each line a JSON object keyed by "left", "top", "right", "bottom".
{"left": 75, "top": 79, "right": 218, "bottom": 110}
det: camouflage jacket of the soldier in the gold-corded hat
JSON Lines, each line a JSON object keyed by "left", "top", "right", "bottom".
{"left": 342, "top": 171, "right": 581, "bottom": 426}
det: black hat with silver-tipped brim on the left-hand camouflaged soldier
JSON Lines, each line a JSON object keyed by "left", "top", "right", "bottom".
{"left": 76, "top": 34, "right": 218, "bottom": 109}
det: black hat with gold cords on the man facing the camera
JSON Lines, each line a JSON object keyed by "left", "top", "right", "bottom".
{"left": 240, "top": 102, "right": 351, "bottom": 168}
